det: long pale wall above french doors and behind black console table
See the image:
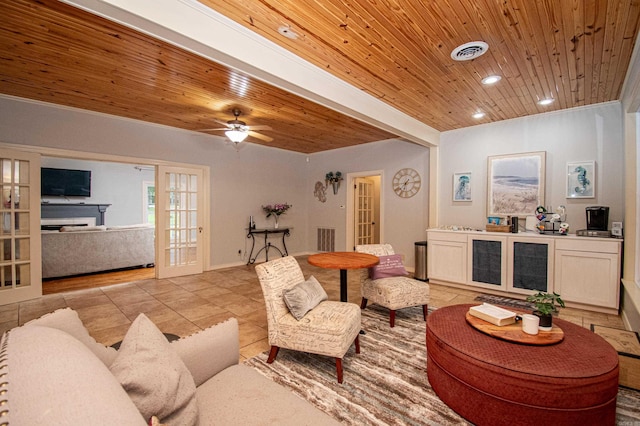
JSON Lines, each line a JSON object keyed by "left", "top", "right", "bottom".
{"left": 0, "top": 96, "right": 308, "bottom": 267}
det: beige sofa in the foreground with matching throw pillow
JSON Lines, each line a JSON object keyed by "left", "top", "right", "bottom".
{"left": 0, "top": 308, "right": 338, "bottom": 426}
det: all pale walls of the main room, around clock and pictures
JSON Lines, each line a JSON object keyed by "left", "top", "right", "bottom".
{"left": 5, "top": 97, "right": 624, "bottom": 286}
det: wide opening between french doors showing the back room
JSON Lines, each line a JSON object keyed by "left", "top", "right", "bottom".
{"left": 40, "top": 153, "right": 157, "bottom": 294}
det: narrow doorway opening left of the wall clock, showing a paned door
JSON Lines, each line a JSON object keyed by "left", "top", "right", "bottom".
{"left": 346, "top": 170, "right": 384, "bottom": 250}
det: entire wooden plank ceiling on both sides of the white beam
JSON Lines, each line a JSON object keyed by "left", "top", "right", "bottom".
{"left": 0, "top": 0, "right": 640, "bottom": 153}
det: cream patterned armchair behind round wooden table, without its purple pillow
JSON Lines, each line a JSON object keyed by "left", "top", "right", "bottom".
{"left": 356, "top": 244, "right": 429, "bottom": 327}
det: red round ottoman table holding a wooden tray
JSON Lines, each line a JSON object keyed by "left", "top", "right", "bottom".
{"left": 427, "top": 305, "right": 618, "bottom": 426}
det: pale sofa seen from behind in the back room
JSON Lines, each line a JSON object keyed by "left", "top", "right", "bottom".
{"left": 42, "top": 225, "right": 155, "bottom": 278}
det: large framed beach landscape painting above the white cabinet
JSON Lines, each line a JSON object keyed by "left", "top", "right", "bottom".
{"left": 487, "top": 151, "right": 546, "bottom": 216}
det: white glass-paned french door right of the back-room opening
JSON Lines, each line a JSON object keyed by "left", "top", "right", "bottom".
{"left": 156, "top": 166, "right": 204, "bottom": 278}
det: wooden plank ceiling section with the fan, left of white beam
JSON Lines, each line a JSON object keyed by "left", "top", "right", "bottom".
{"left": 0, "top": 0, "right": 394, "bottom": 153}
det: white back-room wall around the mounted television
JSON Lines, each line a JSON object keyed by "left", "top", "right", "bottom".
{"left": 41, "top": 157, "right": 155, "bottom": 226}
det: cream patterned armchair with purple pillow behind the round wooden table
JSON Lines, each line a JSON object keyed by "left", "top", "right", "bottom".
{"left": 356, "top": 244, "right": 429, "bottom": 327}
